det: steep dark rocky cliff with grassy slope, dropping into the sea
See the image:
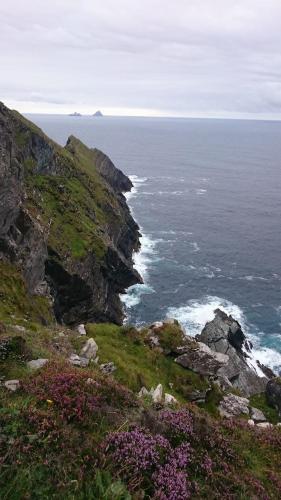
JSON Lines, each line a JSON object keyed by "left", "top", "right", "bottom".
{"left": 0, "top": 104, "right": 141, "bottom": 324}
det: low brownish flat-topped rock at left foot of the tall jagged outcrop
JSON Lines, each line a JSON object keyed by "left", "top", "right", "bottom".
{"left": 175, "top": 342, "right": 228, "bottom": 375}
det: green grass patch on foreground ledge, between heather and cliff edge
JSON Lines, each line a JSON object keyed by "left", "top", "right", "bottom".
{"left": 86, "top": 323, "right": 207, "bottom": 401}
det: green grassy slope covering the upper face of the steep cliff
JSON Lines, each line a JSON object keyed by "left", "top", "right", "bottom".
{"left": 13, "top": 112, "right": 122, "bottom": 260}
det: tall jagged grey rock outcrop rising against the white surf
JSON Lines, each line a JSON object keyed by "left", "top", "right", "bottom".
{"left": 196, "top": 309, "right": 268, "bottom": 396}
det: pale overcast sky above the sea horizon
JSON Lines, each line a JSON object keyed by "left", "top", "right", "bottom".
{"left": 0, "top": 0, "right": 281, "bottom": 119}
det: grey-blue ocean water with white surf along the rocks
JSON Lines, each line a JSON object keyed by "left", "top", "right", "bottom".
{"left": 27, "top": 115, "right": 281, "bottom": 371}
